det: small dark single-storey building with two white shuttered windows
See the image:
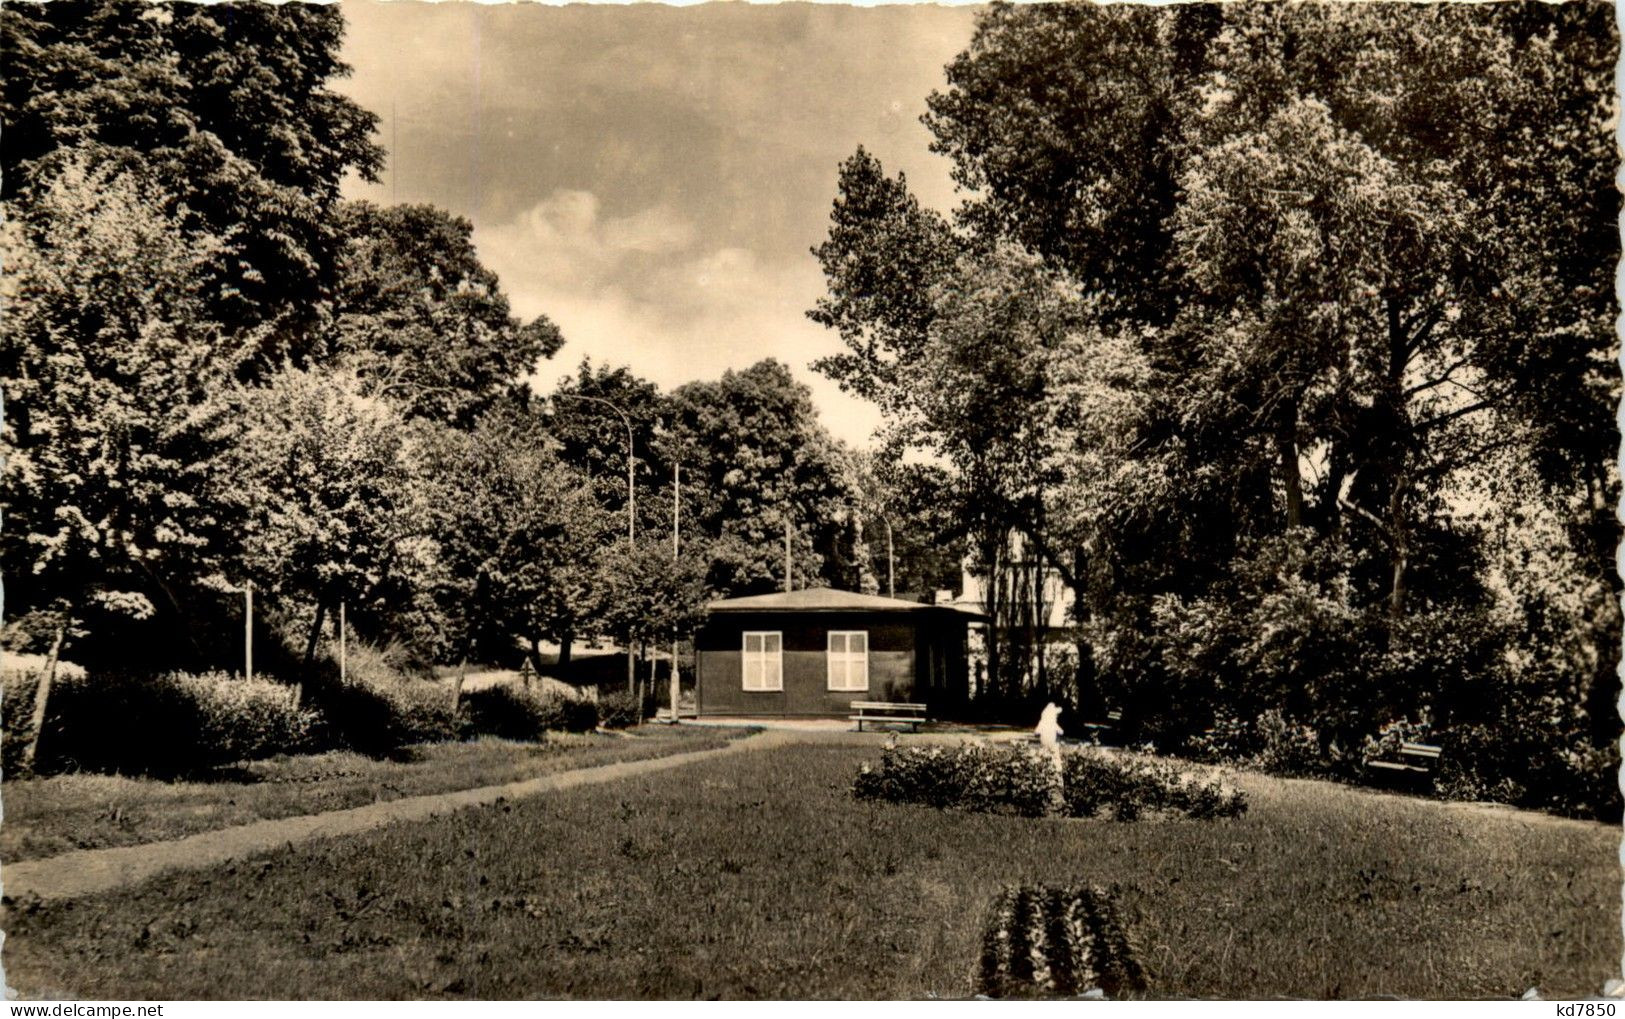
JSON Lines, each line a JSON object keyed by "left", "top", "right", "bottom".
{"left": 694, "top": 587, "right": 982, "bottom": 717}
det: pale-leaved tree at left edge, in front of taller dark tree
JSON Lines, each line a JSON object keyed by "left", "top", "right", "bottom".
{"left": 0, "top": 159, "right": 239, "bottom": 650}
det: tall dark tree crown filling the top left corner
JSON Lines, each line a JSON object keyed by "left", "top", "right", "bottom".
{"left": 0, "top": 0, "right": 384, "bottom": 342}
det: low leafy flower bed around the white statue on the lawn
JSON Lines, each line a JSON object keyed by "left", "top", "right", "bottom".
{"left": 852, "top": 743, "right": 1246, "bottom": 821}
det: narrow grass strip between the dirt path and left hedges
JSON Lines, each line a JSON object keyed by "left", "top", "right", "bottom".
{"left": 0, "top": 726, "right": 743, "bottom": 861}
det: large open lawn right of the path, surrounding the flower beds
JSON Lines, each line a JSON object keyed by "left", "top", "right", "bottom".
{"left": 5, "top": 744, "right": 1620, "bottom": 998}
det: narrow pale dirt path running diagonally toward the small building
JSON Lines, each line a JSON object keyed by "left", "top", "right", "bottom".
{"left": 0, "top": 731, "right": 806, "bottom": 900}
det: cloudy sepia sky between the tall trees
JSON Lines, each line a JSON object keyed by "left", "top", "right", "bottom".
{"left": 338, "top": 2, "right": 973, "bottom": 445}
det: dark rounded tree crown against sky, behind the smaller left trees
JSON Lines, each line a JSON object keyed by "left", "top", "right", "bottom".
{"left": 333, "top": 202, "right": 564, "bottom": 427}
